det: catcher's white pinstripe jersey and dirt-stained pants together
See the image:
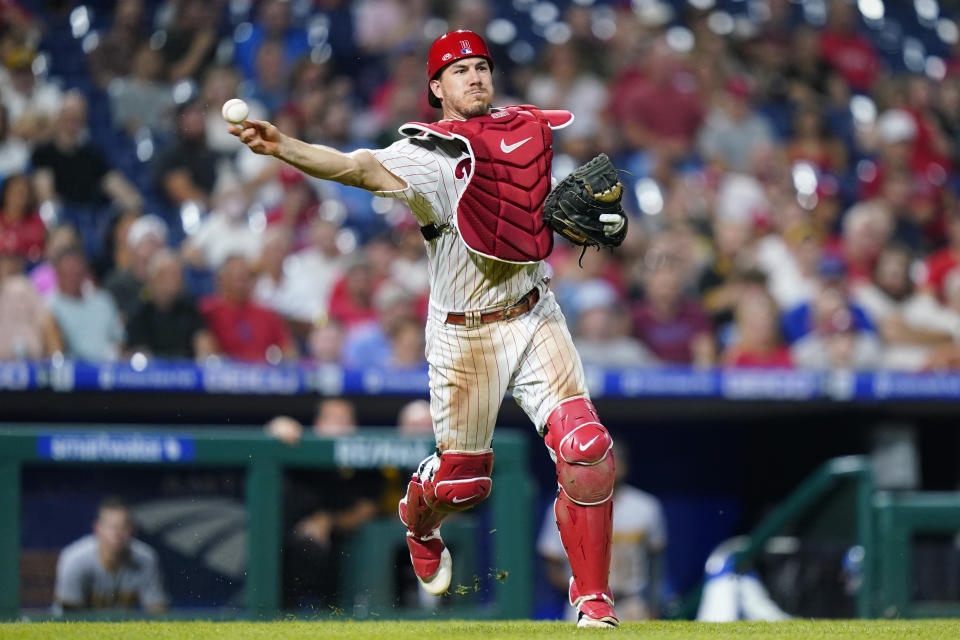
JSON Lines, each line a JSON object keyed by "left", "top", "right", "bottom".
{"left": 373, "top": 129, "right": 588, "bottom": 451}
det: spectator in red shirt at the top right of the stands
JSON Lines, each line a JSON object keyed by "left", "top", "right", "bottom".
{"left": 820, "top": 2, "right": 880, "bottom": 93}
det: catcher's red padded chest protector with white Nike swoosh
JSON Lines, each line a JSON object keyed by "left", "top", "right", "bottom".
{"left": 400, "top": 105, "right": 573, "bottom": 263}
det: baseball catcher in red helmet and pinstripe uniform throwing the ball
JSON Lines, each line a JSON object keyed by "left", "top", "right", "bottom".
{"left": 229, "top": 30, "right": 626, "bottom": 628}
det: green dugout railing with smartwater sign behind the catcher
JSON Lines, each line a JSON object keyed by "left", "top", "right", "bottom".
{"left": 0, "top": 425, "right": 534, "bottom": 619}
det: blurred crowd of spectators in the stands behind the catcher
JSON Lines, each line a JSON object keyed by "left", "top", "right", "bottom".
{"left": 0, "top": 0, "right": 960, "bottom": 370}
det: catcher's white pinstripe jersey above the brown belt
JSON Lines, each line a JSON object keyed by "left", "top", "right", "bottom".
{"left": 373, "top": 138, "right": 546, "bottom": 316}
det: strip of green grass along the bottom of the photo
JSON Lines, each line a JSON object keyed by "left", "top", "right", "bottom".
{"left": 0, "top": 620, "right": 960, "bottom": 640}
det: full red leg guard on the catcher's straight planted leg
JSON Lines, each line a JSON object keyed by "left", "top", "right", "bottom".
{"left": 544, "top": 398, "right": 616, "bottom": 619}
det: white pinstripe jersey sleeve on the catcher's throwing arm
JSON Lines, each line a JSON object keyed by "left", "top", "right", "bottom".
{"left": 372, "top": 138, "right": 443, "bottom": 225}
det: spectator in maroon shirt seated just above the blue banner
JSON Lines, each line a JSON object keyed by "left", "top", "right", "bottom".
{"left": 633, "top": 264, "right": 714, "bottom": 366}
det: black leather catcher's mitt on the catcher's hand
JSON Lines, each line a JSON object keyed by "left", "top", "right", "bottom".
{"left": 543, "top": 153, "right": 627, "bottom": 247}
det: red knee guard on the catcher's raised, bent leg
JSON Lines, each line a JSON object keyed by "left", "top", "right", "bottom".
{"left": 418, "top": 450, "right": 493, "bottom": 513}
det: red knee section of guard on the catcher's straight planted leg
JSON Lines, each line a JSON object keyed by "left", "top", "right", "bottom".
{"left": 544, "top": 398, "right": 614, "bottom": 506}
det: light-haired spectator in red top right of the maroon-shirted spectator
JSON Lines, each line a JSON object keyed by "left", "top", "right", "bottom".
{"left": 722, "top": 290, "right": 793, "bottom": 368}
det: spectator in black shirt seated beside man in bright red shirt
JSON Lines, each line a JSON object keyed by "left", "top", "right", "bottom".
{"left": 127, "top": 249, "right": 216, "bottom": 358}
